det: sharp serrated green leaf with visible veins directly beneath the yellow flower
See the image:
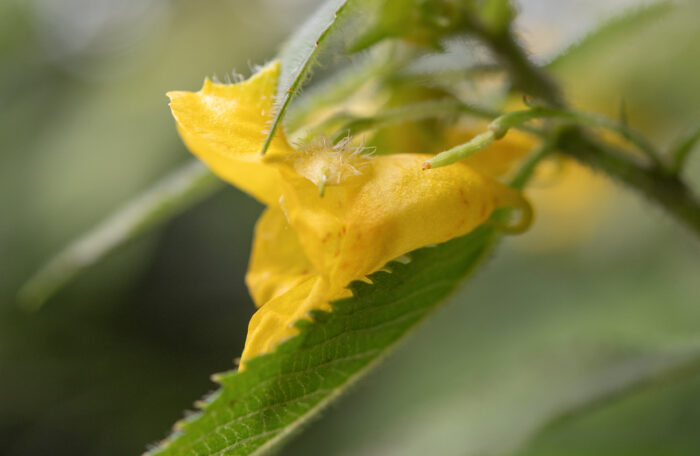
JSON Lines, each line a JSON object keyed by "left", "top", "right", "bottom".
{"left": 149, "top": 225, "right": 498, "bottom": 456}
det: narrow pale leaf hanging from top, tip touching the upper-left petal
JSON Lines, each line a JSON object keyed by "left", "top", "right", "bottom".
{"left": 262, "top": 0, "right": 350, "bottom": 153}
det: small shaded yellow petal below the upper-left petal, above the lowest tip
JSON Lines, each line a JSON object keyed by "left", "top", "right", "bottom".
{"left": 246, "top": 206, "right": 313, "bottom": 307}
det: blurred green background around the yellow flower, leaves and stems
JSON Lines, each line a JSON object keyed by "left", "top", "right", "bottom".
{"left": 0, "top": 0, "right": 700, "bottom": 455}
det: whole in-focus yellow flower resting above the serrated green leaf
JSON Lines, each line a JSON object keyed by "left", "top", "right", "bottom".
{"left": 168, "top": 62, "right": 530, "bottom": 368}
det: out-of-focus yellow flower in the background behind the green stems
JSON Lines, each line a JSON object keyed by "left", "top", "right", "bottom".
{"left": 371, "top": 115, "right": 618, "bottom": 252}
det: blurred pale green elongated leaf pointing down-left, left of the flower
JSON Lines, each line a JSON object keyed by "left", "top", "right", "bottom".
{"left": 18, "top": 160, "right": 223, "bottom": 310}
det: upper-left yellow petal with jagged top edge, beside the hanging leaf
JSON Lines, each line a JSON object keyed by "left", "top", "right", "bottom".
{"left": 168, "top": 61, "right": 292, "bottom": 205}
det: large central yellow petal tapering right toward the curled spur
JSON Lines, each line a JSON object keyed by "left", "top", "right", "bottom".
{"left": 282, "top": 154, "right": 529, "bottom": 292}
